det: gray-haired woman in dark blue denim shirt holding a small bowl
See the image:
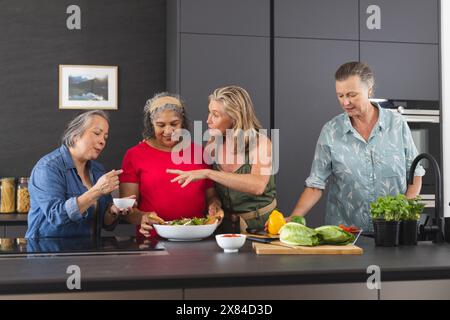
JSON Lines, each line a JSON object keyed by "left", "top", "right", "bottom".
{"left": 26, "top": 110, "right": 128, "bottom": 238}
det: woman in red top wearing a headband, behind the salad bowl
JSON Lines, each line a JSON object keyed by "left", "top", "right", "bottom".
{"left": 120, "top": 93, "right": 223, "bottom": 236}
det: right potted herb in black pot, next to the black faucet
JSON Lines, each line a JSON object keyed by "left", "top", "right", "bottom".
{"left": 400, "top": 196, "right": 425, "bottom": 245}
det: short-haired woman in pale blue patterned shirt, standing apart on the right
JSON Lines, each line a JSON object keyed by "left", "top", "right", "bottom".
{"left": 288, "top": 62, "right": 425, "bottom": 231}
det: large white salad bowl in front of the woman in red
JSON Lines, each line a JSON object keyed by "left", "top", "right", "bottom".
{"left": 153, "top": 222, "right": 218, "bottom": 241}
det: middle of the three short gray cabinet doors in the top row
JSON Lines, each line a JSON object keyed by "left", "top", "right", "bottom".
{"left": 274, "top": 0, "right": 359, "bottom": 40}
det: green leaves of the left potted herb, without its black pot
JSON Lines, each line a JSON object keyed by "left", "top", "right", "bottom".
{"left": 370, "top": 194, "right": 409, "bottom": 221}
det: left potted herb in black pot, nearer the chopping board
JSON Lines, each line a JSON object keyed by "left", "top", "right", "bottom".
{"left": 370, "top": 194, "right": 409, "bottom": 247}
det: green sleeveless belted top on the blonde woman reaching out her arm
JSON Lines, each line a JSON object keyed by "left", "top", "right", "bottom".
{"left": 213, "top": 151, "right": 276, "bottom": 213}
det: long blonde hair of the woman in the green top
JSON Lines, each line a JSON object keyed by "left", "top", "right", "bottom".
{"left": 208, "top": 85, "right": 262, "bottom": 151}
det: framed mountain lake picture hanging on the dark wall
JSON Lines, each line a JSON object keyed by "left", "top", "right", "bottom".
{"left": 59, "top": 65, "right": 118, "bottom": 110}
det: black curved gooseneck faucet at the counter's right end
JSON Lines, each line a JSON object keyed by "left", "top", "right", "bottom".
{"left": 408, "top": 153, "right": 444, "bottom": 243}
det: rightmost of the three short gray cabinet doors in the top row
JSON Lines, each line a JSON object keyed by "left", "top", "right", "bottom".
{"left": 360, "top": 0, "right": 439, "bottom": 43}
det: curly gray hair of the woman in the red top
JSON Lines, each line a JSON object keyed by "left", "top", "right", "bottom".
{"left": 142, "top": 92, "right": 189, "bottom": 139}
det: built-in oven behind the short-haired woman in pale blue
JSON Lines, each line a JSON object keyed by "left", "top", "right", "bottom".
{"left": 377, "top": 99, "right": 442, "bottom": 232}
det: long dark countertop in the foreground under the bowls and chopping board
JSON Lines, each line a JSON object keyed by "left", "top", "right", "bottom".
{"left": 0, "top": 237, "right": 450, "bottom": 294}
